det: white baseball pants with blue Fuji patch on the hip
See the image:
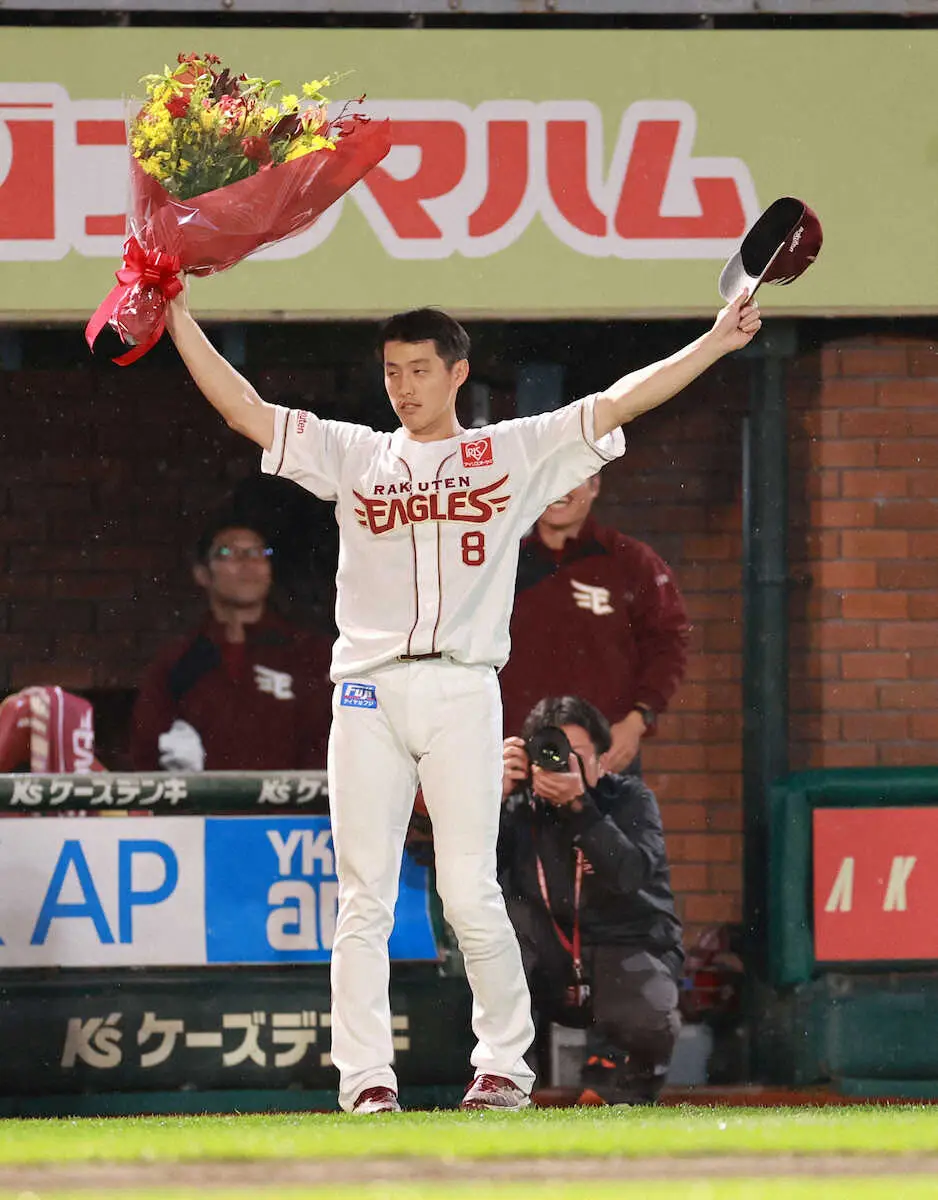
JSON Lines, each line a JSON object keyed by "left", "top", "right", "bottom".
{"left": 329, "top": 659, "right": 534, "bottom": 1111}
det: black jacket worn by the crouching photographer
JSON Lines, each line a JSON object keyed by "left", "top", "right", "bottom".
{"left": 498, "top": 775, "right": 681, "bottom": 954}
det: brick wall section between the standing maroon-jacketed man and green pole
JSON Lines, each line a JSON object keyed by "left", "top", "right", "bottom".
{"left": 600, "top": 362, "right": 747, "bottom": 938}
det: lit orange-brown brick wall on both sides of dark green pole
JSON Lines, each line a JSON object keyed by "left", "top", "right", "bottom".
{"left": 603, "top": 330, "right": 938, "bottom": 938}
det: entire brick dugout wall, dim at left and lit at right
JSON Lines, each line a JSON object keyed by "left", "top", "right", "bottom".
{"left": 0, "top": 326, "right": 938, "bottom": 937}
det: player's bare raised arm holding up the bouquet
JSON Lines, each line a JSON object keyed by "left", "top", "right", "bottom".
{"left": 166, "top": 288, "right": 273, "bottom": 450}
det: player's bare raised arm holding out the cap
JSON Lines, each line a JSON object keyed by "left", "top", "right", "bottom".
{"left": 594, "top": 292, "right": 762, "bottom": 438}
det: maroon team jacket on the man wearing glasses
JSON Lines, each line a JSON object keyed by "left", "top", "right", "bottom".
{"left": 131, "top": 613, "right": 332, "bottom": 770}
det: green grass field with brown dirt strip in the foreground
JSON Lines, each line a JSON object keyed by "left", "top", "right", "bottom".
{"left": 0, "top": 1105, "right": 938, "bottom": 1200}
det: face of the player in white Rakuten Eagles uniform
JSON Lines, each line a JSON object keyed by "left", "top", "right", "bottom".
{"left": 384, "top": 342, "right": 469, "bottom": 442}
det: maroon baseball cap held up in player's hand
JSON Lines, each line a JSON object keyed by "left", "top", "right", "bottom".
{"left": 720, "top": 196, "right": 822, "bottom": 301}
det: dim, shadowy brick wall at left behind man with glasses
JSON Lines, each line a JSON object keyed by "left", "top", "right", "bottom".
{"left": 0, "top": 350, "right": 374, "bottom": 691}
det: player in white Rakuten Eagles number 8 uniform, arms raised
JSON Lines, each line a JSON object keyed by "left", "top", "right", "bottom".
{"left": 167, "top": 285, "right": 762, "bottom": 1112}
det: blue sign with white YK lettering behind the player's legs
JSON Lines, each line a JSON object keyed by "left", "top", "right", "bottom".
{"left": 205, "top": 816, "right": 439, "bottom": 962}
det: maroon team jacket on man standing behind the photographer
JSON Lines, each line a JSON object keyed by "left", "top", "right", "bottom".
{"left": 500, "top": 516, "right": 689, "bottom": 734}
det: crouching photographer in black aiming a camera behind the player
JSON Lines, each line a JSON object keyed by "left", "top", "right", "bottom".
{"left": 498, "top": 696, "right": 684, "bottom": 1104}
